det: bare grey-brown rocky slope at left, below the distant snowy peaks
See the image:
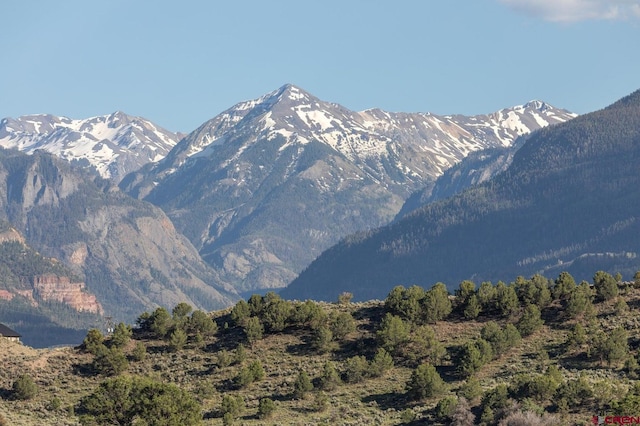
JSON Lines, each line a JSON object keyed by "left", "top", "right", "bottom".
{"left": 0, "top": 150, "right": 237, "bottom": 325}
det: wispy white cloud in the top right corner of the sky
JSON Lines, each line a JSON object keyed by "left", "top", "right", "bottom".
{"left": 499, "top": 0, "right": 640, "bottom": 22}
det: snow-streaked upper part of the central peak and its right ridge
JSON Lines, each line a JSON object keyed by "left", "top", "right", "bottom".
{"left": 162, "top": 84, "right": 575, "bottom": 188}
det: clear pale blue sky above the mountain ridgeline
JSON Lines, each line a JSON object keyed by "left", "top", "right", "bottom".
{"left": 0, "top": 0, "right": 640, "bottom": 132}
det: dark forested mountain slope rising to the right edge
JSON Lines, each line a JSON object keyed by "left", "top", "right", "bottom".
{"left": 281, "top": 91, "right": 640, "bottom": 300}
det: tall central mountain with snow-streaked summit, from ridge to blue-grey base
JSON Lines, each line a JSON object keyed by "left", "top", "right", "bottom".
{"left": 121, "top": 85, "right": 575, "bottom": 290}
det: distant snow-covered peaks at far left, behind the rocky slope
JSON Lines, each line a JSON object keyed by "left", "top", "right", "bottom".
{"left": 0, "top": 112, "right": 182, "bottom": 182}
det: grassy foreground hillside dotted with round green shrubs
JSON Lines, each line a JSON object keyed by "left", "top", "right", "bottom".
{"left": 0, "top": 273, "right": 640, "bottom": 425}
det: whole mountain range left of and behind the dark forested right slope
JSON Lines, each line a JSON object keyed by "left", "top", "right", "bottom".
{"left": 0, "top": 85, "right": 575, "bottom": 342}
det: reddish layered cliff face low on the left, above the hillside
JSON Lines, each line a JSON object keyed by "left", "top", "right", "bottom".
{"left": 33, "top": 275, "right": 103, "bottom": 315}
